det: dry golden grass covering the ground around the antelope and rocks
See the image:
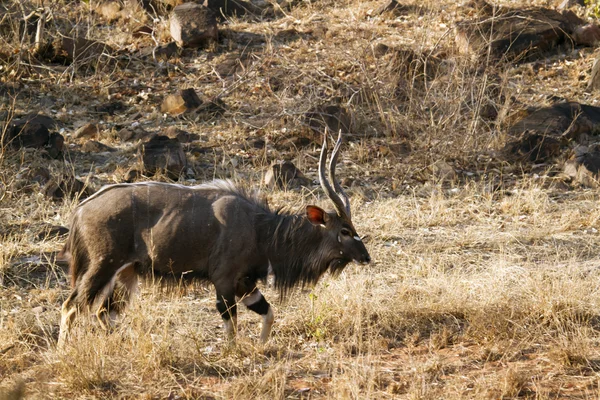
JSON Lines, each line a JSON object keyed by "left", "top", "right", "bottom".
{"left": 0, "top": 0, "right": 600, "bottom": 399}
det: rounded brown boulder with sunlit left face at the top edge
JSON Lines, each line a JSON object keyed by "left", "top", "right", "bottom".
{"left": 170, "top": 3, "right": 219, "bottom": 47}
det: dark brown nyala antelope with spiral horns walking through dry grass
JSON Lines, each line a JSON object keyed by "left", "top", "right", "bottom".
{"left": 59, "top": 133, "right": 371, "bottom": 343}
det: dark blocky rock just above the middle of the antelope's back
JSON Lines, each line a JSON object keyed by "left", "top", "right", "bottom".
{"left": 141, "top": 135, "right": 187, "bottom": 179}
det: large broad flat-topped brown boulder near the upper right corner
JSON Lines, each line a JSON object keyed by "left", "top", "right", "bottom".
{"left": 455, "top": 8, "right": 575, "bottom": 61}
